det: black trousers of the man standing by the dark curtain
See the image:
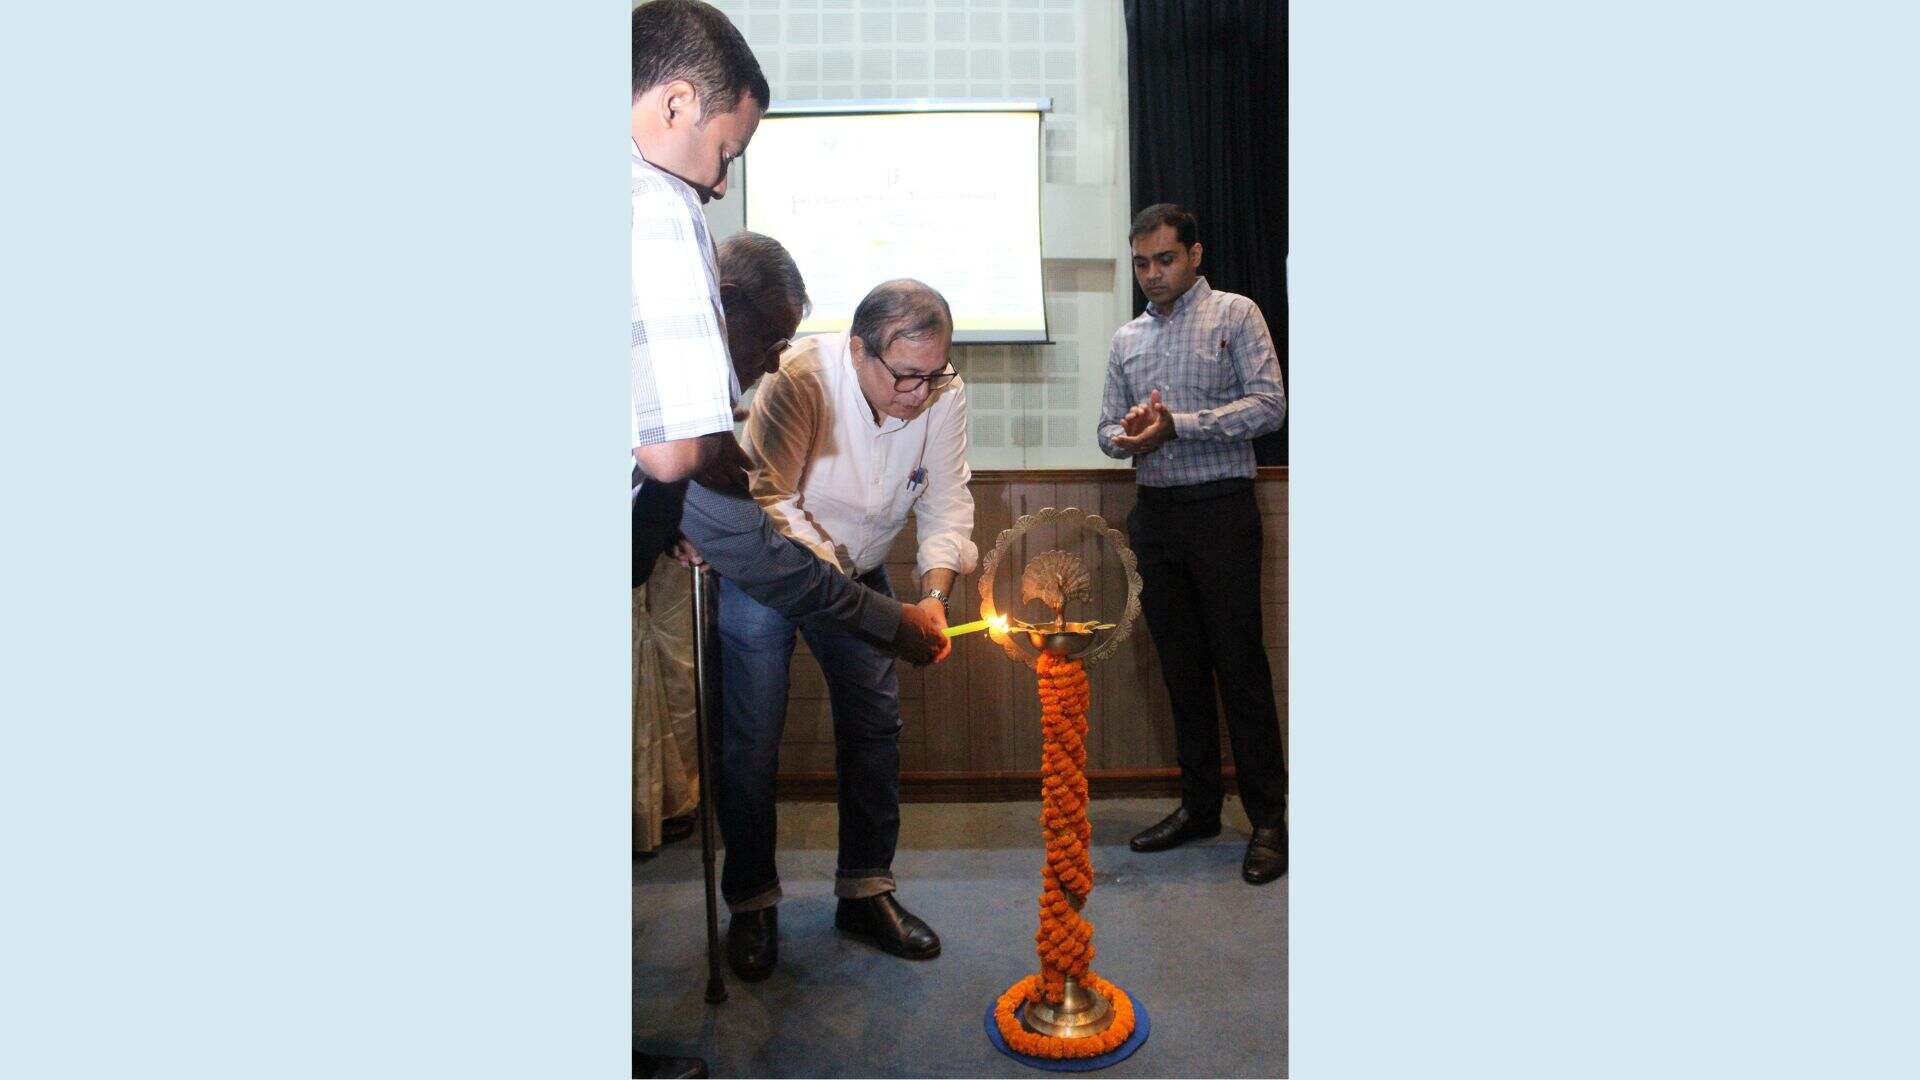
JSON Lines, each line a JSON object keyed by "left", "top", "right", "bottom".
{"left": 1127, "top": 480, "right": 1286, "bottom": 828}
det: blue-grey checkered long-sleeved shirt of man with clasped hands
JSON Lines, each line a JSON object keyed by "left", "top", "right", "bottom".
{"left": 1100, "top": 277, "right": 1286, "bottom": 488}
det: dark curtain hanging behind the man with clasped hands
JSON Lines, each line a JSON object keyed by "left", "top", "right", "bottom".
{"left": 1127, "top": 0, "right": 1292, "bottom": 465}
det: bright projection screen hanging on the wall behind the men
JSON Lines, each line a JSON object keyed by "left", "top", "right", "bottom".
{"left": 741, "top": 102, "right": 1046, "bottom": 344}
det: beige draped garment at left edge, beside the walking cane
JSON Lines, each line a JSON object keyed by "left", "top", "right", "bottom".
{"left": 634, "top": 555, "right": 701, "bottom": 851}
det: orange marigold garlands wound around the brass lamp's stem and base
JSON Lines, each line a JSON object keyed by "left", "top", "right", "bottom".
{"left": 993, "top": 653, "right": 1133, "bottom": 1059}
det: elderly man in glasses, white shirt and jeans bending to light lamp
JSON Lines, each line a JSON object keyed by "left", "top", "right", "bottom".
{"left": 720, "top": 279, "right": 979, "bottom": 980}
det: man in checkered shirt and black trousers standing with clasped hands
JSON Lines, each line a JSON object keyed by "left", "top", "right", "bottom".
{"left": 1100, "top": 202, "right": 1286, "bottom": 884}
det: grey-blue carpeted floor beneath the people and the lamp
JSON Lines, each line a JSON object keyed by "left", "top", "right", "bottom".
{"left": 634, "top": 799, "right": 1288, "bottom": 1076}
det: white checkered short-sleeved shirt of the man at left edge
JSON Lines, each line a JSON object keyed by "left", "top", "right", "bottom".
{"left": 632, "top": 146, "right": 739, "bottom": 446}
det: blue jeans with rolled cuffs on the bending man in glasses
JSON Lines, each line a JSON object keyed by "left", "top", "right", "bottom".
{"left": 716, "top": 569, "right": 900, "bottom": 911}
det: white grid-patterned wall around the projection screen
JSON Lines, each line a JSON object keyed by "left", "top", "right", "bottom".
{"left": 707, "top": 0, "right": 1133, "bottom": 469}
